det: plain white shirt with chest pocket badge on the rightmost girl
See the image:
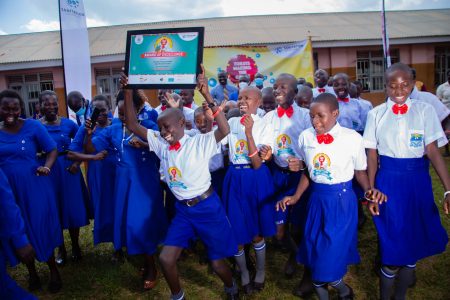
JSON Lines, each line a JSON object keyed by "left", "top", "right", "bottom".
{"left": 364, "top": 98, "right": 447, "bottom": 158}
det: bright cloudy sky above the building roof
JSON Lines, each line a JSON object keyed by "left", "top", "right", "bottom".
{"left": 0, "top": 0, "right": 450, "bottom": 34}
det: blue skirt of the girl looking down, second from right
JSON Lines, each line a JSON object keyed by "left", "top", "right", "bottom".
{"left": 297, "top": 181, "right": 360, "bottom": 282}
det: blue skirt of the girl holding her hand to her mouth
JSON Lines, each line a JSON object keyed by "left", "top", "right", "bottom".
{"left": 222, "top": 165, "right": 276, "bottom": 245}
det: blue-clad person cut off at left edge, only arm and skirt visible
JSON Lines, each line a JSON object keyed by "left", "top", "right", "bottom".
{"left": 0, "top": 169, "right": 37, "bottom": 300}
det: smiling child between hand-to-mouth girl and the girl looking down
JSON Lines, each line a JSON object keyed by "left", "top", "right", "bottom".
{"left": 264, "top": 74, "right": 311, "bottom": 276}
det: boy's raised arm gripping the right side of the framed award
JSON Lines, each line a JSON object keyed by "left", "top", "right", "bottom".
{"left": 197, "top": 65, "right": 230, "bottom": 142}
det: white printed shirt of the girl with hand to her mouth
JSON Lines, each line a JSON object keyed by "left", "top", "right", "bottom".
{"left": 222, "top": 115, "right": 273, "bottom": 165}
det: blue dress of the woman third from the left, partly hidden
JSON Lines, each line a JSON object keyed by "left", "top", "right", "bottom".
{"left": 69, "top": 125, "right": 117, "bottom": 245}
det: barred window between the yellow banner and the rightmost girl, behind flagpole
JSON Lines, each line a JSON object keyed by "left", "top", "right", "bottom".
{"left": 356, "top": 49, "right": 399, "bottom": 92}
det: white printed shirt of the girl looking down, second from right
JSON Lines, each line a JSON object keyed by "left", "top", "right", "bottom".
{"left": 298, "top": 122, "right": 367, "bottom": 184}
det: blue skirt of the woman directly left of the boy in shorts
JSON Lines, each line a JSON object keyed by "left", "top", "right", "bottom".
{"left": 114, "top": 164, "right": 167, "bottom": 255}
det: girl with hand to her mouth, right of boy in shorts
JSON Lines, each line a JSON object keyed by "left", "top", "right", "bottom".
{"left": 222, "top": 87, "right": 276, "bottom": 294}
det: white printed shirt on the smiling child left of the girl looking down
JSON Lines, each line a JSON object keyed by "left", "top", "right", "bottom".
{"left": 264, "top": 105, "right": 311, "bottom": 168}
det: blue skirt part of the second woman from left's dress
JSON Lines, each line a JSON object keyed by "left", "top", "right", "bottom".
{"left": 50, "top": 155, "right": 90, "bottom": 229}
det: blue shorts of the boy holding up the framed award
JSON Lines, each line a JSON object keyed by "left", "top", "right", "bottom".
{"left": 164, "top": 192, "right": 238, "bottom": 260}
